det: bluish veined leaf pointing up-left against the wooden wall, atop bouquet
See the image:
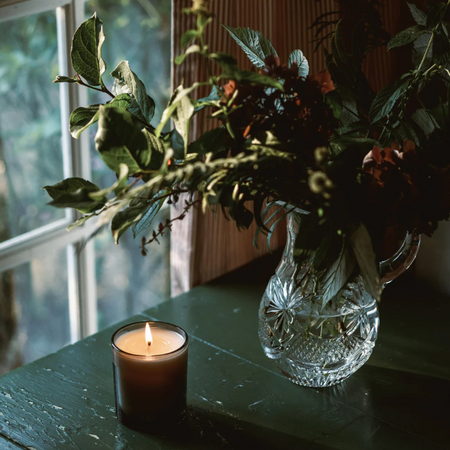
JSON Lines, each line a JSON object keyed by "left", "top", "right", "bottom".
{"left": 222, "top": 25, "right": 278, "bottom": 69}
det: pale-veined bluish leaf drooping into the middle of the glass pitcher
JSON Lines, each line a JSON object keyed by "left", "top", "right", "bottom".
{"left": 319, "top": 242, "right": 355, "bottom": 307}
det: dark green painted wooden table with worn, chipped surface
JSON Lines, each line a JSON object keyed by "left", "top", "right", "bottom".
{"left": 0, "top": 258, "right": 450, "bottom": 450}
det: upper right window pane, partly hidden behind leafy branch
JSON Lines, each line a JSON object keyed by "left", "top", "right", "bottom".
{"left": 86, "top": 0, "right": 171, "bottom": 187}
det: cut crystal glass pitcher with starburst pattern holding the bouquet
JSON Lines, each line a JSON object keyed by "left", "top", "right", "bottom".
{"left": 259, "top": 210, "right": 420, "bottom": 387}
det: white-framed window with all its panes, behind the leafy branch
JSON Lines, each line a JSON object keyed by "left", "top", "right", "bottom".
{"left": 0, "top": 0, "right": 170, "bottom": 373}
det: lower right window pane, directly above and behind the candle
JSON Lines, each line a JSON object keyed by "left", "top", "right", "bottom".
{"left": 95, "top": 208, "right": 170, "bottom": 329}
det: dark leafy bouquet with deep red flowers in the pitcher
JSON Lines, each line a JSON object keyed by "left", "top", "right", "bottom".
{"left": 45, "top": 0, "right": 450, "bottom": 299}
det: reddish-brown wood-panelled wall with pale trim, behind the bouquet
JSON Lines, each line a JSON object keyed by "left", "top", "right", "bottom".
{"left": 171, "top": 0, "right": 404, "bottom": 294}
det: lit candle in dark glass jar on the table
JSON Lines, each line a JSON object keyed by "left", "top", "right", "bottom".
{"left": 112, "top": 322, "right": 188, "bottom": 431}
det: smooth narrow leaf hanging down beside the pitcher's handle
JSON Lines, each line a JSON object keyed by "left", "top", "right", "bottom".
{"left": 350, "top": 224, "right": 382, "bottom": 300}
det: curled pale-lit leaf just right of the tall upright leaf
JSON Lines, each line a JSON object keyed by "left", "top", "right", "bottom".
{"left": 111, "top": 61, "right": 155, "bottom": 123}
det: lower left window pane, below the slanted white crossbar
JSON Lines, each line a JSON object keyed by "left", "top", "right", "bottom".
{"left": 0, "top": 248, "right": 70, "bottom": 374}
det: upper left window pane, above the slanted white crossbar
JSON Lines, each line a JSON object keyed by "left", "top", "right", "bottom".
{"left": 0, "top": 11, "right": 64, "bottom": 242}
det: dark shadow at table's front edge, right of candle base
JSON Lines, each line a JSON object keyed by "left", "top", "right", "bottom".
{"left": 129, "top": 407, "right": 331, "bottom": 450}
